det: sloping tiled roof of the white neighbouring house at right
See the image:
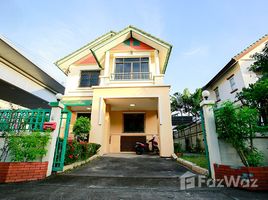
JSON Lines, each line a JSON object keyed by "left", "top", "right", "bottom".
{"left": 203, "top": 34, "right": 268, "bottom": 89}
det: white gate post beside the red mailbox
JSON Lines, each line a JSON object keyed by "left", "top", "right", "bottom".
{"left": 46, "top": 102, "right": 64, "bottom": 176}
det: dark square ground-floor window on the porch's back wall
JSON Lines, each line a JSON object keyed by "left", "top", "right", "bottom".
{"left": 124, "top": 113, "right": 145, "bottom": 133}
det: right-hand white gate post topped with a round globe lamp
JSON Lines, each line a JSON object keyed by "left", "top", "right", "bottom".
{"left": 200, "top": 91, "right": 221, "bottom": 179}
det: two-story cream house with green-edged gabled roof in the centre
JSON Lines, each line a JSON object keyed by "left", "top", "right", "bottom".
{"left": 56, "top": 26, "right": 173, "bottom": 157}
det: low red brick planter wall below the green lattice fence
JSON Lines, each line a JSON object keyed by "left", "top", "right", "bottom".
{"left": 0, "top": 162, "right": 48, "bottom": 183}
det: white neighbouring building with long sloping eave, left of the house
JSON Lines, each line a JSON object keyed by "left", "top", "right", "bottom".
{"left": 0, "top": 36, "right": 64, "bottom": 109}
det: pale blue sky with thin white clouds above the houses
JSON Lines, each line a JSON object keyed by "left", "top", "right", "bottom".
{"left": 0, "top": 0, "right": 268, "bottom": 92}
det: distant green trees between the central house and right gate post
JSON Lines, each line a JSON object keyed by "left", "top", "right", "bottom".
{"left": 171, "top": 88, "right": 202, "bottom": 117}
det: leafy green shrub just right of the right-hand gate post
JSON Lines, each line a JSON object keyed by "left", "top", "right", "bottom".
{"left": 215, "top": 101, "right": 263, "bottom": 166}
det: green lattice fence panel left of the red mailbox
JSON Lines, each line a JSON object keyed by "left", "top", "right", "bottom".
{"left": 0, "top": 109, "right": 50, "bottom": 132}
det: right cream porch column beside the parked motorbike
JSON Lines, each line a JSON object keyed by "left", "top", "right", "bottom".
{"left": 158, "top": 95, "right": 174, "bottom": 157}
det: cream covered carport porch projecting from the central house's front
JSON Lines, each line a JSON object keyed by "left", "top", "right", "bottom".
{"left": 89, "top": 86, "right": 173, "bottom": 157}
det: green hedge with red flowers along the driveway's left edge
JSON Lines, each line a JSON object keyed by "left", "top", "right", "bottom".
{"left": 64, "top": 140, "right": 101, "bottom": 165}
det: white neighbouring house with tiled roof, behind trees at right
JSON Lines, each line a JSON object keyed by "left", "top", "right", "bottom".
{"left": 203, "top": 34, "right": 268, "bottom": 103}
